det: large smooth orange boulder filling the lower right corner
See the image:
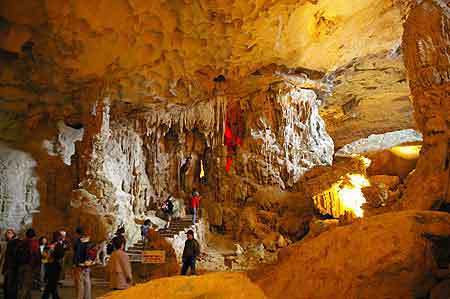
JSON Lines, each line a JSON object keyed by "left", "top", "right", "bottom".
{"left": 250, "top": 211, "right": 450, "bottom": 299}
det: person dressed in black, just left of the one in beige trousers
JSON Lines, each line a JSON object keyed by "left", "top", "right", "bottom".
{"left": 42, "top": 231, "right": 64, "bottom": 299}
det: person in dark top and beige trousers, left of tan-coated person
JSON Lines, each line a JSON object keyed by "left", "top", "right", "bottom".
{"left": 72, "top": 226, "right": 91, "bottom": 299}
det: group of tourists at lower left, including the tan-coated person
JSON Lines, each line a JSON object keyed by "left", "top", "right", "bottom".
{"left": 0, "top": 226, "right": 132, "bottom": 299}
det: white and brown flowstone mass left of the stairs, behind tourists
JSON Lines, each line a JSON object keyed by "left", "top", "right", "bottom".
{"left": 69, "top": 96, "right": 153, "bottom": 244}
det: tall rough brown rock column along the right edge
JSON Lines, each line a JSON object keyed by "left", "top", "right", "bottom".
{"left": 403, "top": 0, "right": 450, "bottom": 209}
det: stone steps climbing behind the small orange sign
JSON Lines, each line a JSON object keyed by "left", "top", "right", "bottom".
{"left": 127, "top": 215, "right": 192, "bottom": 263}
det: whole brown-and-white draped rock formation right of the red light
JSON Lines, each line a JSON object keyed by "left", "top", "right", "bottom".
{"left": 217, "top": 83, "right": 334, "bottom": 201}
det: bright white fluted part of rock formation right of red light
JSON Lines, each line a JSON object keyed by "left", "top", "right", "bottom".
{"left": 251, "top": 84, "right": 334, "bottom": 188}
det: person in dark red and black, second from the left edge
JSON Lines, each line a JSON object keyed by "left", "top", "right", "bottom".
{"left": 16, "top": 228, "right": 41, "bottom": 299}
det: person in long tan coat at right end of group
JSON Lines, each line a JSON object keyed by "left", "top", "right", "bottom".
{"left": 107, "top": 238, "right": 133, "bottom": 290}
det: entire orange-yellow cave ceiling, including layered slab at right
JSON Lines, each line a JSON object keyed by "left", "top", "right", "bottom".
{"left": 0, "top": 0, "right": 414, "bottom": 148}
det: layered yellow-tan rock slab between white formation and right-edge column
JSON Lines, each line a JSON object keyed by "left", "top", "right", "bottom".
{"left": 321, "top": 51, "right": 416, "bottom": 148}
